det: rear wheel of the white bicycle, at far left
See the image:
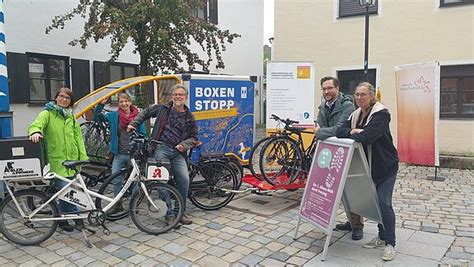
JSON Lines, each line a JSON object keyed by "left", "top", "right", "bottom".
{"left": 0, "top": 189, "right": 59, "bottom": 246}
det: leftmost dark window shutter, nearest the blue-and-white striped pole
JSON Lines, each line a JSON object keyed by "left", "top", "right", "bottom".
{"left": 7, "top": 52, "right": 30, "bottom": 103}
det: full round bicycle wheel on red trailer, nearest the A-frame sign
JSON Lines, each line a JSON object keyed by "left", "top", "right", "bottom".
{"left": 260, "top": 136, "right": 303, "bottom": 186}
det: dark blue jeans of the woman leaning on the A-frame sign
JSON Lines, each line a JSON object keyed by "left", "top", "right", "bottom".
{"left": 375, "top": 167, "right": 398, "bottom": 247}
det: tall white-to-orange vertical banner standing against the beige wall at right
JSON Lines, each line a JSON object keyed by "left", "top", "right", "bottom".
{"left": 395, "top": 62, "right": 440, "bottom": 166}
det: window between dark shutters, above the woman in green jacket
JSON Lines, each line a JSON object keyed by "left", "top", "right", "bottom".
{"left": 27, "top": 53, "right": 69, "bottom": 103}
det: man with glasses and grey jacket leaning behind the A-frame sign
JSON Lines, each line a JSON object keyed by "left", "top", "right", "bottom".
{"left": 315, "top": 77, "right": 364, "bottom": 240}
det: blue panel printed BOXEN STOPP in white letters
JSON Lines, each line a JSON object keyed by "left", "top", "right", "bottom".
{"left": 189, "top": 79, "right": 255, "bottom": 161}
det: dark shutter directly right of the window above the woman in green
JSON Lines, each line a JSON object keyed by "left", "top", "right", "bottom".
{"left": 71, "top": 58, "right": 91, "bottom": 99}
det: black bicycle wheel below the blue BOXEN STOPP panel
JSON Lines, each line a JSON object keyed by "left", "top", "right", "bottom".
{"left": 189, "top": 161, "right": 239, "bottom": 210}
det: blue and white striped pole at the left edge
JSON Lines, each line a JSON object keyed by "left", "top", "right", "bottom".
{"left": 0, "top": 0, "right": 12, "bottom": 138}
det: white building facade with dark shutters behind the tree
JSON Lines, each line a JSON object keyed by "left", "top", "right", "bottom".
{"left": 3, "top": 0, "right": 263, "bottom": 136}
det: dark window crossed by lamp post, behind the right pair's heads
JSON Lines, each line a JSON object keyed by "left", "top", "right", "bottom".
{"left": 337, "top": 69, "right": 377, "bottom": 96}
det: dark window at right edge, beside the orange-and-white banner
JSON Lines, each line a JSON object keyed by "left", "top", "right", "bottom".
{"left": 440, "top": 64, "right": 474, "bottom": 118}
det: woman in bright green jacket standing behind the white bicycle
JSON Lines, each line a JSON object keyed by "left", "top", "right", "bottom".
{"left": 28, "top": 87, "right": 88, "bottom": 232}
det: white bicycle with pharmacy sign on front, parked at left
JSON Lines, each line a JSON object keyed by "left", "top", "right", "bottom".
{"left": 0, "top": 132, "right": 184, "bottom": 247}
